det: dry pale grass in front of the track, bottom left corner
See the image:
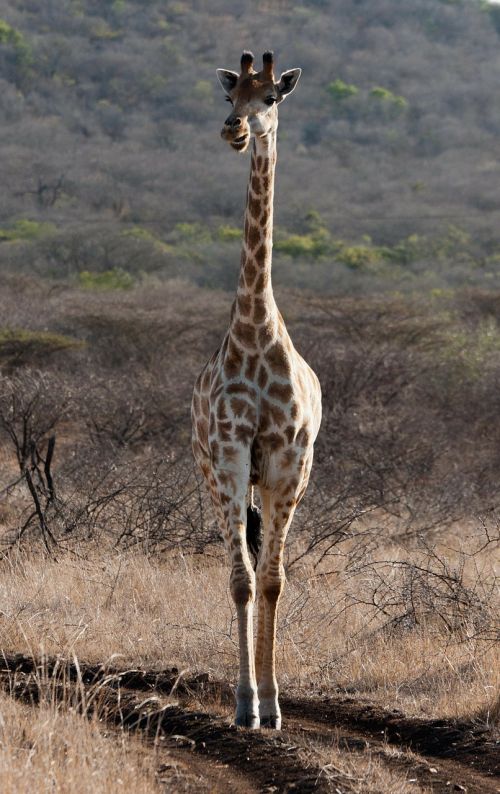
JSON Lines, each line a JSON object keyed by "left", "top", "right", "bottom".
{"left": 0, "top": 693, "right": 161, "bottom": 794}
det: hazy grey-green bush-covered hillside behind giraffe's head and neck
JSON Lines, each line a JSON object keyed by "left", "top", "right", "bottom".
{"left": 0, "top": 0, "right": 500, "bottom": 292}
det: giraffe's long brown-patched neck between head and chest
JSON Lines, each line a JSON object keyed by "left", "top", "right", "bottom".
{"left": 235, "top": 131, "right": 278, "bottom": 340}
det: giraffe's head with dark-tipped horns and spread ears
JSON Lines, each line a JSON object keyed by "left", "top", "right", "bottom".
{"left": 217, "top": 52, "right": 301, "bottom": 152}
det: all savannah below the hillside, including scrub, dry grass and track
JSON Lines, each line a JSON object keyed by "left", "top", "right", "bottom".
{"left": 0, "top": 277, "right": 500, "bottom": 792}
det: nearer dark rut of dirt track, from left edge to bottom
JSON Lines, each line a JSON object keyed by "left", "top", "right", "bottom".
{"left": 0, "top": 655, "right": 330, "bottom": 794}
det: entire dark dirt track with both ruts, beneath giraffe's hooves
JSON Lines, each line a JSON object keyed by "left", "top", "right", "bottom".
{"left": 0, "top": 655, "right": 500, "bottom": 794}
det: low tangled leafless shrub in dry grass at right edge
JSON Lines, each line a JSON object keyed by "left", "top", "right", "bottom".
{"left": 340, "top": 526, "right": 500, "bottom": 642}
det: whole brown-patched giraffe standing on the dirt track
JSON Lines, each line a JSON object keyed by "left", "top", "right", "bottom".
{"left": 192, "top": 52, "right": 321, "bottom": 729}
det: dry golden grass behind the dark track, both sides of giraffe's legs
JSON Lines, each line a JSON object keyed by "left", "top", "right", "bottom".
{"left": 0, "top": 532, "right": 500, "bottom": 722}
